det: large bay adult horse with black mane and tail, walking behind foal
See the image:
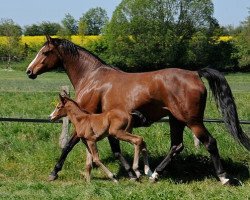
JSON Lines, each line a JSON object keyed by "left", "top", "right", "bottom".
{"left": 26, "top": 36, "right": 250, "bottom": 184}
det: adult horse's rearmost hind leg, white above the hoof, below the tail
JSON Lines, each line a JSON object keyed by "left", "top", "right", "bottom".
{"left": 188, "top": 122, "right": 230, "bottom": 185}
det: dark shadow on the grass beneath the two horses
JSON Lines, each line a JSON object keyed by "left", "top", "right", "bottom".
{"left": 102, "top": 155, "right": 250, "bottom": 183}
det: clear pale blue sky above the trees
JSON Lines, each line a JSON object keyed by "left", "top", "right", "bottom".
{"left": 0, "top": 0, "right": 250, "bottom": 27}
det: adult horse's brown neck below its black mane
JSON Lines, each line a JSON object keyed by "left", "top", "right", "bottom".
{"left": 63, "top": 50, "right": 104, "bottom": 91}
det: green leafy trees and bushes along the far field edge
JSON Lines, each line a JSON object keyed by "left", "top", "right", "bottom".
{"left": 0, "top": 0, "right": 250, "bottom": 71}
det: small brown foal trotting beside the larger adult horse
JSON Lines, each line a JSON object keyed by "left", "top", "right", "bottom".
{"left": 50, "top": 95, "right": 152, "bottom": 182}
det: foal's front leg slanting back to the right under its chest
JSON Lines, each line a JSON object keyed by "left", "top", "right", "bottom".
{"left": 86, "top": 140, "right": 117, "bottom": 182}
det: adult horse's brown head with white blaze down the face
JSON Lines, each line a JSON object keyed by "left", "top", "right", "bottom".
{"left": 26, "top": 36, "right": 65, "bottom": 79}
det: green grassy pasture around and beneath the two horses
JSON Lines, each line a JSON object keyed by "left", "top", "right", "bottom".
{"left": 0, "top": 70, "right": 250, "bottom": 200}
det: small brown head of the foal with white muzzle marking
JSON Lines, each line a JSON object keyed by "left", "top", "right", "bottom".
{"left": 49, "top": 94, "right": 71, "bottom": 121}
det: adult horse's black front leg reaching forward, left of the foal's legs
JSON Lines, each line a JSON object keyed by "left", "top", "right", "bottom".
{"left": 49, "top": 131, "right": 80, "bottom": 181}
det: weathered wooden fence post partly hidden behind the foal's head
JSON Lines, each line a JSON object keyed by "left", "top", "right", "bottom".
{"left": 59, "top": 86, "right": 70, "bottom": 149}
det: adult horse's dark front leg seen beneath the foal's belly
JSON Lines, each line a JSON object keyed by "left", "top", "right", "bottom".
{"left": 108, "top": 136, "right": 136, "bottom": 179}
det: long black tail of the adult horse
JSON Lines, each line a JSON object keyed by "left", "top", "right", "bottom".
{"left": 198, "top": 68, "right": 250, "bottom": 151}
